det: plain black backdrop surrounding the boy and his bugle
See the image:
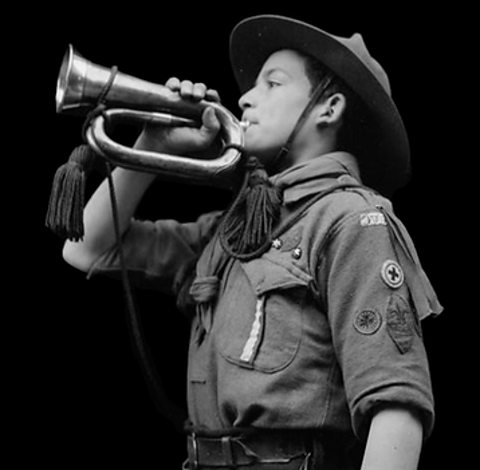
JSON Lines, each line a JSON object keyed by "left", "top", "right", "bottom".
{"left": 14, "top": 2, "right": 468, "bottom": 470}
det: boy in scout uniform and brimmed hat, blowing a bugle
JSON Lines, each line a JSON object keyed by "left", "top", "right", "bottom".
{"left": 64, "top": 15, "right": 441, "bottom": 470}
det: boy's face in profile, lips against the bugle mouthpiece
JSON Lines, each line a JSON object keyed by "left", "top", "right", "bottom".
{"left": 239, "top": 49, "right": 311, "bottom": 164}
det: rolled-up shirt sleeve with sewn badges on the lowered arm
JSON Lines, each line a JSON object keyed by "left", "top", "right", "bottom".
{"left": 319, "top": 212, "right": 434, "bottom": 437}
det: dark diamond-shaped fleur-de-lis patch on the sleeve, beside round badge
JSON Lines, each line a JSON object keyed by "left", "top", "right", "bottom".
{"left": 387, "top": 295, "right": 414, "bottom": 354}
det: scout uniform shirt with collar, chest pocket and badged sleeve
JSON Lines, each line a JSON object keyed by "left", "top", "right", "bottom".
{"left": 91, "top": 152, "right": 441, "bottom": 444}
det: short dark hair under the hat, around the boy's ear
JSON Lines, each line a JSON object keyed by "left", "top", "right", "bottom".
{"left": 297, "top": 51, "right": 372, "bottom": 158}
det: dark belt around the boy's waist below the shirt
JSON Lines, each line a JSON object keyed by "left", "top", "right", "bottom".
{"left": 184, "top": 430, "right": 319, "bottom": 470}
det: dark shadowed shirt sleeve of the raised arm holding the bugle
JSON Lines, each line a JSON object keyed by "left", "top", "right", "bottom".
{"left": 87, "top": 212, "right": 221, "bottom": 295}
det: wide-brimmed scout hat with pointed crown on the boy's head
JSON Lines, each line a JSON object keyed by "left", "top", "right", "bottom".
{"left": 230, "top": 15, "right": 410, "bottom": 195}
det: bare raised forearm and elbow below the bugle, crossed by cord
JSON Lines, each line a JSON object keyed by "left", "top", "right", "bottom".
{"left": 63, "top": 134, "right": 159, "bottom": 271}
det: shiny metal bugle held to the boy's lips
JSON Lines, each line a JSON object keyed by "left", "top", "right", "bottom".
{"left": 56, "top": 45, "right": 243, "bottom": 187}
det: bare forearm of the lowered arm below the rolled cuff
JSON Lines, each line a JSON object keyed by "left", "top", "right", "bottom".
{"left": 361, "top": 408, "right": 423, "bottom": 470}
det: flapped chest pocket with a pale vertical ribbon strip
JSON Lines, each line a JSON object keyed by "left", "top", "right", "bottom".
{"left": 218, "top": 255, "right": 311, "bottom": 373}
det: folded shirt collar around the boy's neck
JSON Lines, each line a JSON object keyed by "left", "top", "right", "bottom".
{"left": 271, "top": 152, "right": 361, "bottom": 204}
